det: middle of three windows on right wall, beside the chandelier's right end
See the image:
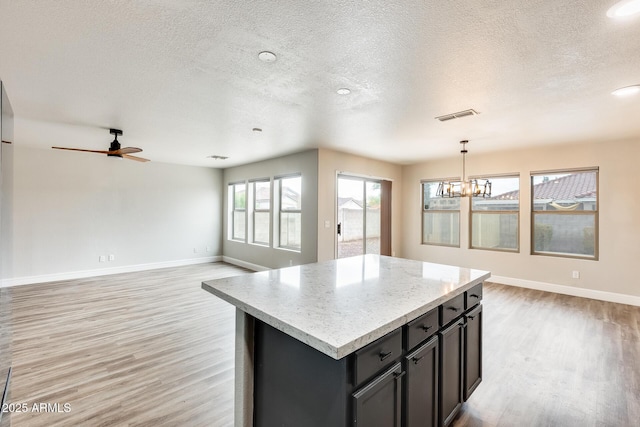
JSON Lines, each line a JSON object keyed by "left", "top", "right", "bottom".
{"left": 471, "top": 175, "right": 520, "bottom": 252}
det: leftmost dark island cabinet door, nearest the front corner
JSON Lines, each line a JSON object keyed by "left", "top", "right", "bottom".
{"left": 353, "top": 363, "right": 405, "bottom": 427}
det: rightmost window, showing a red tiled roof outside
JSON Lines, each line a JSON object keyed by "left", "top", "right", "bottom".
{"left": 531, "top": 168, "right": 598, "bottom": 259}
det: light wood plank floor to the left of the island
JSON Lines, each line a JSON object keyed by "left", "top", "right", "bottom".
{"left": 0, "top": 263, "right": 247, "bottom": 427}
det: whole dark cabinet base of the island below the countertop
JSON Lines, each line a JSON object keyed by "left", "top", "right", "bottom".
{"left": 254, "top": 284, "right": 482, "bottom": 427}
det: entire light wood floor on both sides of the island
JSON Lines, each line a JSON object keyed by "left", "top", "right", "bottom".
{"left": 0, "top": 263, "right": 640, "bottom": 427}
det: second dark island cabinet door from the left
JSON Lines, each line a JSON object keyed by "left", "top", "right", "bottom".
{"left": 404, "top": 336, "right": 440, "bottom": 427}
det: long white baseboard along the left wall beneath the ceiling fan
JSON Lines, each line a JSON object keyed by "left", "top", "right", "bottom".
{"left": 0, "top": 255, "right": 222, "bottom": 288}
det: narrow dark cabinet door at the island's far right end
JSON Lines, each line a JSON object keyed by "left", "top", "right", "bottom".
{"left": 464, "top": 305, "right": 482, "bottom": 401}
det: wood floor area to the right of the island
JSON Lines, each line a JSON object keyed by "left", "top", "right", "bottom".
{"left": 453, "top": 284, "right": 640, "bottom": 427}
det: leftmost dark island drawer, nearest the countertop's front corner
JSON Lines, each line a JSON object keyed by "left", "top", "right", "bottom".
{"left": 355, "top": 328, "right": 402, "bottom": 386}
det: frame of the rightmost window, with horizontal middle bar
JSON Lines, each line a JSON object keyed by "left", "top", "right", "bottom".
{"left": 529, "top": 166, "right": 600, "bottom": 261}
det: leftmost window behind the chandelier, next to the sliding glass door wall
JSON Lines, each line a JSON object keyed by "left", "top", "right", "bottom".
{"left": 422, "top": 181, "right": 460, "bottom": 247}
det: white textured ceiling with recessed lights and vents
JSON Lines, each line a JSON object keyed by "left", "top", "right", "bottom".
{"left": 0, "top": 0, "right": 640, "bottom": 167}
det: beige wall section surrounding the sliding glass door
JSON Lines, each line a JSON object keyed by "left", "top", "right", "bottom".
{"left": 318, "top": 149, "right": 403, "bottom": 261}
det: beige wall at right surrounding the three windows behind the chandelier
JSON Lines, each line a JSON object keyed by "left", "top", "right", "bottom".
{"left": 402, "top": 140, "right": 640, "bottom": 297}
